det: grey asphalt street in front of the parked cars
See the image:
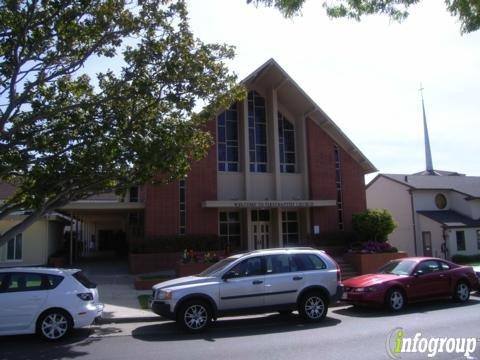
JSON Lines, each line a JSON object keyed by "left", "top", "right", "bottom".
{"left": 0, "top": 295, "right": 480, "bottom": 360}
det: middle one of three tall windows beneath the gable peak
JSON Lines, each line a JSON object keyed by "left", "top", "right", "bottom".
{"left": 248, "top": 91, "right": 268, "bottom": 172}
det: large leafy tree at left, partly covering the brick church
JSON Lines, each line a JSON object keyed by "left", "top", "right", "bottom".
{"left": 0, "top": 0, "right": 243, "bottom": 246}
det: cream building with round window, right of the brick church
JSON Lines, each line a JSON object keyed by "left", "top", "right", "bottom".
{"left": 367, "top": 171, "right": 480, "bottom": 258}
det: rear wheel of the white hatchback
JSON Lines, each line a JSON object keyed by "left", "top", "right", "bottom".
{"left": 37, "top": 309, "right": 73, "bottom": 341}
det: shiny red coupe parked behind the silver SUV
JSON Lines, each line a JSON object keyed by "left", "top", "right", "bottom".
{"left": 342, "top": 257, "right": 479, "bottom": 311}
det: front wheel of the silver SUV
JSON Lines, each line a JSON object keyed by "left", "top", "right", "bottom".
{"left": 177, "top": 300, "right": 212, "bottom": 333}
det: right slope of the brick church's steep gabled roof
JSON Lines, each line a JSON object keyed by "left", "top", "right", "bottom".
{"left": 241, "top": 59, "right": 378, "bottom": 174}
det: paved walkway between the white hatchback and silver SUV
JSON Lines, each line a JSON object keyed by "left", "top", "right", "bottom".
{"left": 75, "top": 260, "right": 162, "bottom": 323}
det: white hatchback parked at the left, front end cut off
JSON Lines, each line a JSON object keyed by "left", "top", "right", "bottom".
{"left": 0, "top": 267, "right": 103, "bottom": 340}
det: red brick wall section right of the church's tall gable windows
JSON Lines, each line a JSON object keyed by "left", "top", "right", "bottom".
{"left": 306, "top": 119, "right": 366, "bottom": 232}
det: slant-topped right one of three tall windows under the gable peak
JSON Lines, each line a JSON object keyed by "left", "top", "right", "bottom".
{"left": 278, "top": 113, "right": 295, "bottom": 173}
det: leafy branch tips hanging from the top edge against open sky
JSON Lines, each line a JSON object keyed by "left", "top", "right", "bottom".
{"left": 247, "top": 0, "right": 480, "bottom": 33}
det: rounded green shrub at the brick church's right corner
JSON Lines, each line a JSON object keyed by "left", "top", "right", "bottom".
{"left": 352, "top": 209, "right": 397, "bottom": 242}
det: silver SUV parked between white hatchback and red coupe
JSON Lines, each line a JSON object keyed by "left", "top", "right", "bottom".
{"left": 150, "top": 248, "right": 342, "bottom": 332}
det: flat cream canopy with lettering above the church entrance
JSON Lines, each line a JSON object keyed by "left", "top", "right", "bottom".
{"left": 202, "top": 200, "right": 337, "bottom": 209}
